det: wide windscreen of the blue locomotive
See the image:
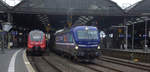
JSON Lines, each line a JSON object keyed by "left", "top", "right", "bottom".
{"left": 77, "top": 30, "right": 98, "bottom": 40}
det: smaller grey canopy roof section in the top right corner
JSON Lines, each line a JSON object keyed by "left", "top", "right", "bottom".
{"left": 126, "top": 0, "right": 150, "bottom": 16}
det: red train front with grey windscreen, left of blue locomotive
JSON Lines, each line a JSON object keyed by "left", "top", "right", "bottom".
{"left": 27, "top": 30, "right": 46, "bottom": 55}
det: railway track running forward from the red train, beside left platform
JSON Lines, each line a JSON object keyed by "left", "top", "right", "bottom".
{"left": 28, "top": 54, "right": 95, "bottom": 72}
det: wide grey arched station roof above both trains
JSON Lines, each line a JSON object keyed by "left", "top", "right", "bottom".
{"left": 0, "top": 0, "right": 124, "bottom": 16}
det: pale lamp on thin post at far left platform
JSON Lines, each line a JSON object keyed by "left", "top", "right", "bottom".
{"left": 2, "top": 22, "right": 12, "bottom": 48}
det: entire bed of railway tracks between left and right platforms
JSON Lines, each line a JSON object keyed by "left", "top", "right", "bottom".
{"left": 28, "top": 54, "right": 150, "bottom": 72}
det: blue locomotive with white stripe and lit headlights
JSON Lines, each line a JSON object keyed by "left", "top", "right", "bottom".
{"left": 55, "top": 26, "right": 100, "bottom": 60}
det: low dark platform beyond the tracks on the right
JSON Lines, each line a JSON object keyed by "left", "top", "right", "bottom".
{"left": 101, "top": 48, "right": 150, "bottom": 63}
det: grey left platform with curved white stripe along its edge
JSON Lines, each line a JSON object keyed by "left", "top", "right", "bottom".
{"left": 0, "top": 48, "right": 29, "bottom": 72}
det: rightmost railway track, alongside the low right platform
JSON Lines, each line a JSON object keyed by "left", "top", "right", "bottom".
{"left": 98, "top": 56, "right": 150, "bottom": 72}
